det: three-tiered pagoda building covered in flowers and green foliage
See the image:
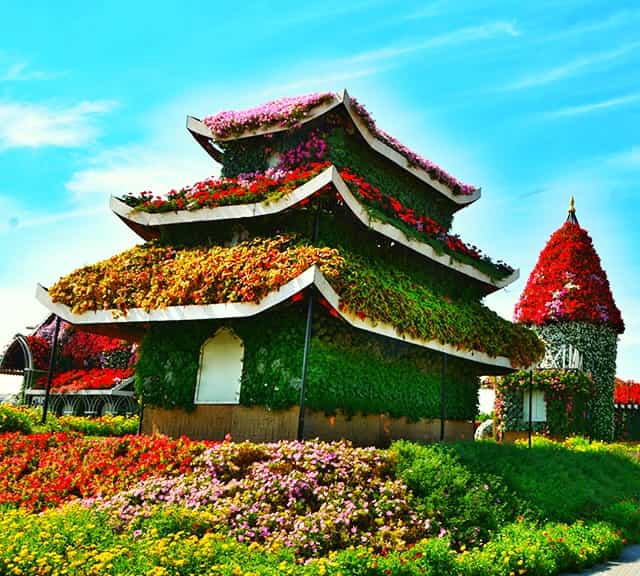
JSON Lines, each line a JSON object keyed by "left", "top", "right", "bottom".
{"left": 38, "top": 92, "right": 543, "bottom": 444}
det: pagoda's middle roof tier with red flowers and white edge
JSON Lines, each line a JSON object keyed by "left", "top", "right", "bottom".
{"left": 111, "top": 163, "right": 519, "bottom": 293}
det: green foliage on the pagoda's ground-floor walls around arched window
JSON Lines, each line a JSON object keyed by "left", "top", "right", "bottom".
{"left": 136, "top": 305, "right": 478, "bottom": 420}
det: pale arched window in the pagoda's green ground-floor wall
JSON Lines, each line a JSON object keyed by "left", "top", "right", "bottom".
{"left": 195, "top": 328, "right": 244, "bottom": 404}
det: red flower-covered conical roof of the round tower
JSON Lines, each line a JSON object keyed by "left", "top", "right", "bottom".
{"left": 515, "top": 222, "right": 624, "bottom": 334}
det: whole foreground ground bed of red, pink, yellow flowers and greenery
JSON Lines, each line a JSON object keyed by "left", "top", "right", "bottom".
{"left": 0, "top": 426, "right": 640, "bottom": 576}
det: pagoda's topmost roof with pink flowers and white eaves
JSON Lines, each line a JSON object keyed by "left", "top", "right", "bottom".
{"left": 187, "top": 90, "right": 480, "bottom": 208}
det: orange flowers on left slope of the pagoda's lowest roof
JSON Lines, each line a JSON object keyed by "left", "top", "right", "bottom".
{"left": 49, "top": 236, "right": 343, "bottom": 314}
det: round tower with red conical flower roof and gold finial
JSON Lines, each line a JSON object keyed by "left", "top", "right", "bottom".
{"left": 515, "top": 198, "right": 624, "bottom": 440}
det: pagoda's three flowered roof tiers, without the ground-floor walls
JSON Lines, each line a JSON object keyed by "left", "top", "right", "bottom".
{"left": 38, "top": 92, "right": 541, "bottom": 370}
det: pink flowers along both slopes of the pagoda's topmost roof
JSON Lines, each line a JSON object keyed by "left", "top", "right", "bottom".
{"left": 203, "top": 92, "right": 477, "bottom": 195}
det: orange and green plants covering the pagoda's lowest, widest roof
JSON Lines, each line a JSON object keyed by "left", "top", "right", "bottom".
{"left": 49, "top": 236, "right": 543, "bottom": 365}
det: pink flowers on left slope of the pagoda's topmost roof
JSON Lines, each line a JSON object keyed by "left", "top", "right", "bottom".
{"left": 203, "top": 92, "right": 335, "bottom": 138}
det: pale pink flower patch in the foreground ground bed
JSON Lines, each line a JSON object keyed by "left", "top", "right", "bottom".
{"left": 85, "top": 442, "right": 428, "bottom": 557}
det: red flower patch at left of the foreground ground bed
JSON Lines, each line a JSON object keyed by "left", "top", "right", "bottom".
{"left": 0, "top": 432, "right": 213, "bottom": 511}
